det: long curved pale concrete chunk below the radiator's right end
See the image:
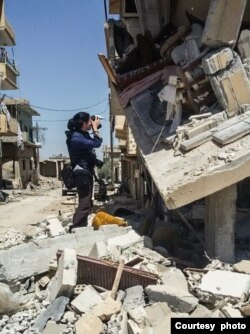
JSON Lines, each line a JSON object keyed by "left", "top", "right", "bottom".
{"left": 145, "top": 285, "right": 198, "bottom": 313}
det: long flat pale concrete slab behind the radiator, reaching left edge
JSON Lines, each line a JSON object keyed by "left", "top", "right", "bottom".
{"left": 0, "top": 227, "right": 131, "bottom": 282}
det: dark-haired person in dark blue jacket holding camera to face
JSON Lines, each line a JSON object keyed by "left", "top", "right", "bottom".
{"left": 65, "top": 112, "right": 102, "bottom": 232}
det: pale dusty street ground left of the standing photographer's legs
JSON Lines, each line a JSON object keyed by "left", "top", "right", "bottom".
{"left": 0, "top": 188, "right": 74, "bottom": 233}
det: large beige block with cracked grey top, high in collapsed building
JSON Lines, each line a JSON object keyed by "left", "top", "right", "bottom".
{"left": 202, "top": 48, "right": 250, "bottom": 117}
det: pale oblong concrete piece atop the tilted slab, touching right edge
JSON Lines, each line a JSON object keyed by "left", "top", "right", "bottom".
{"left": 213, "top": 121, "right": 250, "bottom": 145}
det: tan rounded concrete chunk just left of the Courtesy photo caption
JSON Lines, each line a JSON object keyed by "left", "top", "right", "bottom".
{"left": 145, "top": 302, "right": 171, "bottom": 327}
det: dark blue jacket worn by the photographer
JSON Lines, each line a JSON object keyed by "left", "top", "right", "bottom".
{"left": 66, "top": 131, "right": 102, "bottom": 173}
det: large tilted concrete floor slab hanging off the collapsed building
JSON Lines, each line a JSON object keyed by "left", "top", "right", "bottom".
{"left": 124, "top": 103, "right": 250, "bottom": 209}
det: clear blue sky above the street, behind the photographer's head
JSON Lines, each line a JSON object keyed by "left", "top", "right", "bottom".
{"left": 5, "top": 0, "right": 109, "bottom": 158}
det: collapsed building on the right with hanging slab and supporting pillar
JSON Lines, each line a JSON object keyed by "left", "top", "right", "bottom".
{"left": 99, "top": 0, "right": 250, "bottom": 262}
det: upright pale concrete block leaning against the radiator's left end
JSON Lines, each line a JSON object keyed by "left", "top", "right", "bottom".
{"left": 49, "top": 248, "right": 78, "bottom": 301}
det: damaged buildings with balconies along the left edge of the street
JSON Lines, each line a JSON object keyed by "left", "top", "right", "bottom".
{"left": 0, "top": 0, "right": 41, "bottom": 189}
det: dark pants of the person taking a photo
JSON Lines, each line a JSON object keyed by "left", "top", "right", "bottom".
{"left": 71, "top": 169, "right": 93, "bottom": 229}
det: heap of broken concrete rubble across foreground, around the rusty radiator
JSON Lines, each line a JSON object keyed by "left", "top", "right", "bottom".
{"left": 0, "top": 202, "right": 250, "bottom": 334}
